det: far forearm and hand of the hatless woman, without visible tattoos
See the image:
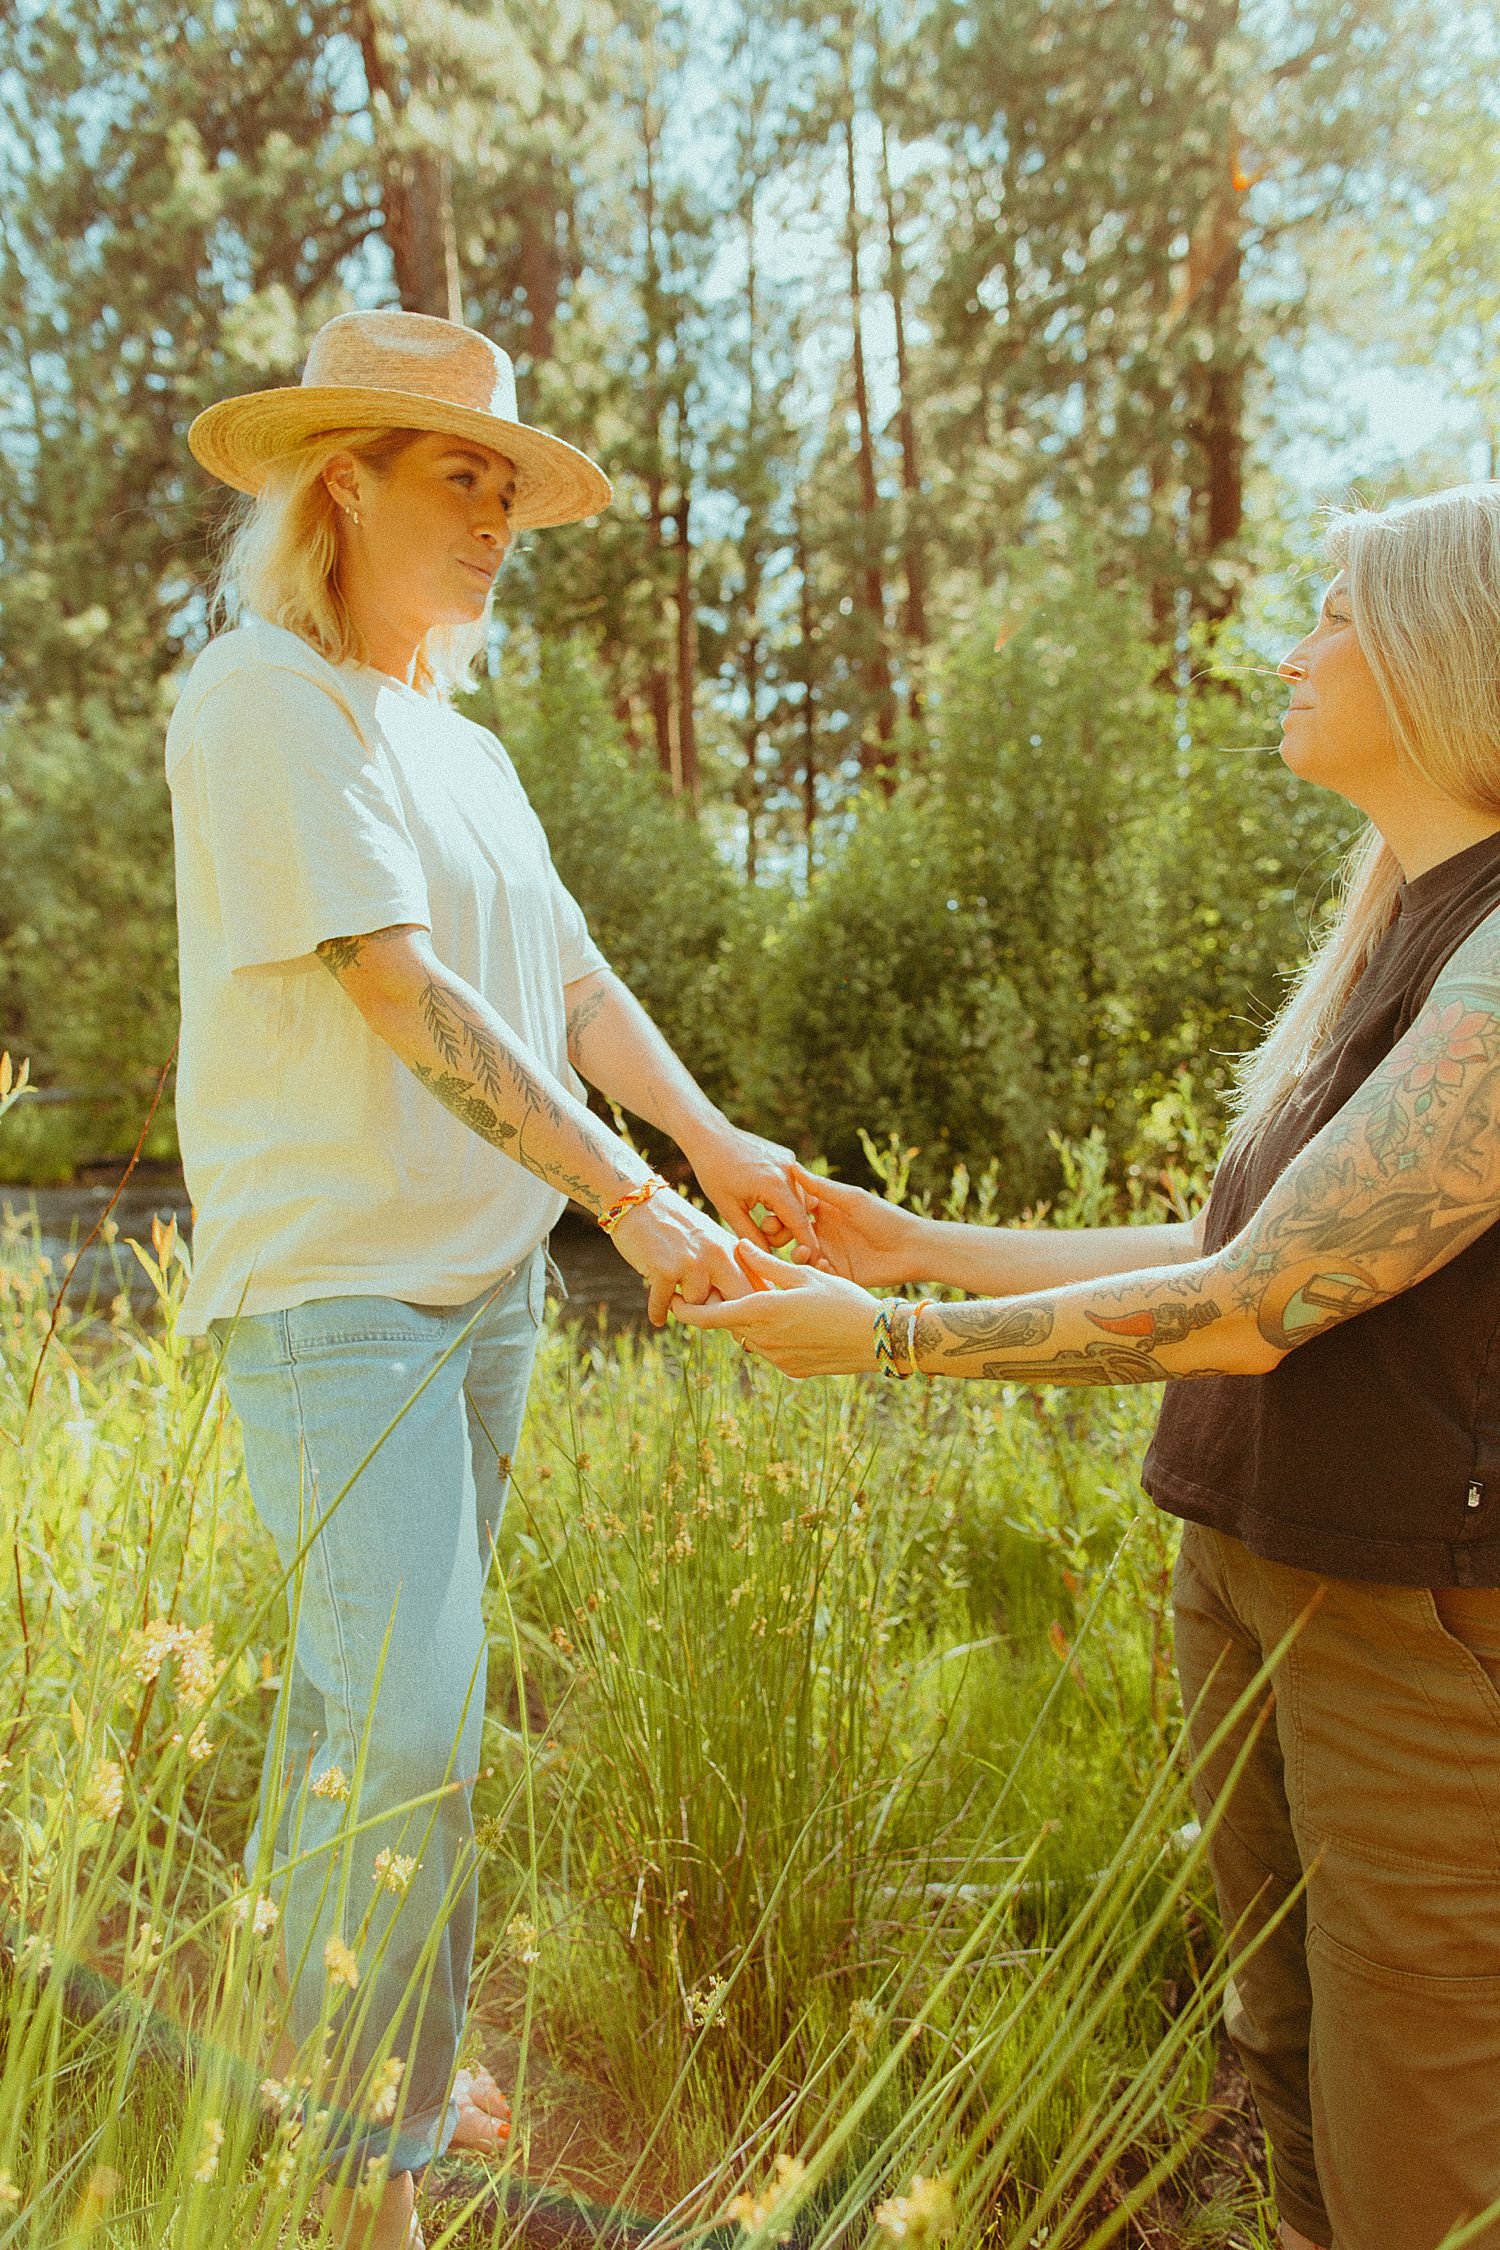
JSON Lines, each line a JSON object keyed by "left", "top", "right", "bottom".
{"left": 796, "top": 1168, "right": 1208, "bottom": 1296}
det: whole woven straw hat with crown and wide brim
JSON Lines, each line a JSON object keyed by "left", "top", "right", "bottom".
{"left": 187, "top": 313, "right": 609, "bottom": 531}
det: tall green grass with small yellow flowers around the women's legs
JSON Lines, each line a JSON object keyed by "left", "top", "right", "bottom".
{"left": 0, "top": 1159, "right": 1304, "bottom": 2250}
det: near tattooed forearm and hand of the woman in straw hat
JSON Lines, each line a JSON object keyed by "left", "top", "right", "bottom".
{"left": 317, "top": 923, "right": 747, "bottom": 1325}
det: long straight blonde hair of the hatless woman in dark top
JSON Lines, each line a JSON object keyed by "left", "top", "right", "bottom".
{"left": 1232, "top": 484, "right": 1500, "bottom": 1143}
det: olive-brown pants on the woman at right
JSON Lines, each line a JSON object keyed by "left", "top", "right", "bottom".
{"left": 1174, "top": 1523, "right": 1500, "bottom": 2250}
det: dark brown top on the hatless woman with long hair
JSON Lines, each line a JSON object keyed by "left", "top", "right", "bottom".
{"left": 1140, "top": 835, "right": 1500, "bottom": 1586}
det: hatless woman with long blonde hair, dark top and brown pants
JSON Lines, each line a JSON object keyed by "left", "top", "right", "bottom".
{"left": 677, "top": 484, "right": 1500, "bottom": 2250}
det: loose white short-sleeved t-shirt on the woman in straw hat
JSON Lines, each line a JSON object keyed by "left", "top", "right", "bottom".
{"left": 166, "top": 617, "right": 607, "bottom": 1337}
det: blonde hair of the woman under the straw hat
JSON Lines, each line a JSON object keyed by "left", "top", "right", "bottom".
{"left": 209, "top": 428, "right": 490, "bottom": 702}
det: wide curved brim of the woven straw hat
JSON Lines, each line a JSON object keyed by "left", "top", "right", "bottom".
{"left": 187, "top": 383, "right": 614, "bottom": 531}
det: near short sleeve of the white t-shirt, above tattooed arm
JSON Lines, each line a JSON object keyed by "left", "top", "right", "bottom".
{"left": 193, "top": 666, "right": 432, "bottom": 970}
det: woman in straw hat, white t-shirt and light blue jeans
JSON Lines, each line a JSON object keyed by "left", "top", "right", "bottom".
{"left": 166, "top": 313, "right": 814, "bottom": 2246}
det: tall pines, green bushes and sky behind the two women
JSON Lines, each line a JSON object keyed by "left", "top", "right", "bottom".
{"left": 0, "top": 0, "right": 1500, "bottom": 1208}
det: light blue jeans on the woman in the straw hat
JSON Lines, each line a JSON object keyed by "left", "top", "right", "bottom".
{"left": 214, "top": 1249, "right": 546, "bottom": 2171}
